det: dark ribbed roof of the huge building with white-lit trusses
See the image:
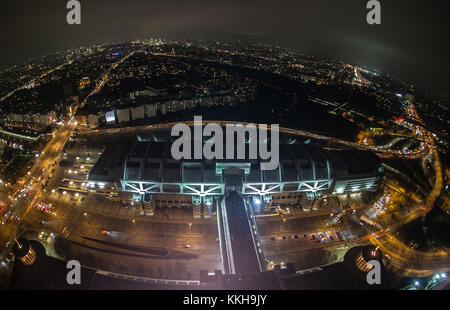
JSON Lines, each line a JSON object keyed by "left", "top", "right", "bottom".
{"left": 89, "top": 141, "right": 381, "bottom": 184}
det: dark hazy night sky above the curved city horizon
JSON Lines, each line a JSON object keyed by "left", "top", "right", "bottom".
{"left": 0, "top": 0, "right": 450, "bottom": 95}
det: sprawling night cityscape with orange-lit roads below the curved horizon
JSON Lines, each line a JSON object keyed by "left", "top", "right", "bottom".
{"left": 0, "top": 1, "right": 450, "bottom": 296}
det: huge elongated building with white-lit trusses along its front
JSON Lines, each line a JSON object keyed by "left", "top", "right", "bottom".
{"left": 87, "top": 130, "right": 383, "bottom": 217}
